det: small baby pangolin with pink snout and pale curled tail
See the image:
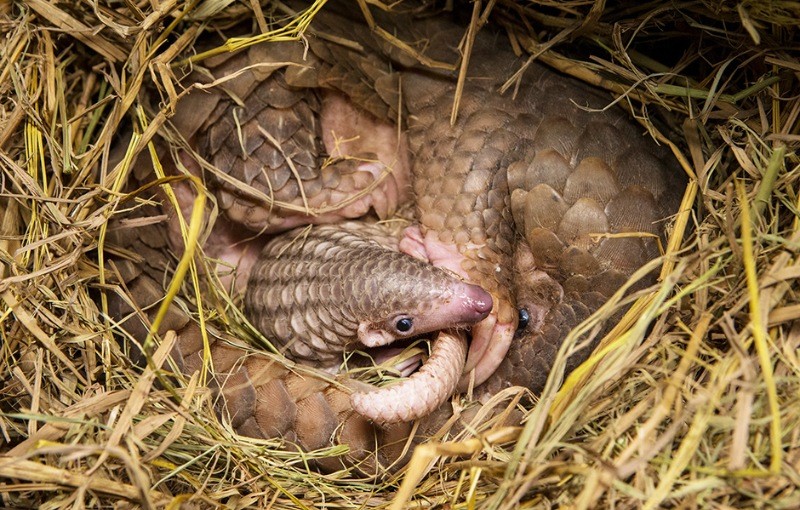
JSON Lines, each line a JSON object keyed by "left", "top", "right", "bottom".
{"left": 244, "top": 222, "right": 492, "bottom": 423}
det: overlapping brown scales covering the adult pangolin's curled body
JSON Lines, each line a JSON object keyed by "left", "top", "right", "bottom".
{"left": 104, "top": 1, "right": 680, "bottom": 472}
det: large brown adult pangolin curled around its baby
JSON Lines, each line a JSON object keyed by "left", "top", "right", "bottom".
{"left": 104, "top": 1, "right": 682, "bottom": 469}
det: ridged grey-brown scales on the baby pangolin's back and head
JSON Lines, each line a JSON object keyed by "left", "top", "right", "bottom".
{"left": 244, "top": 223, "right": 476, "bottom": 365}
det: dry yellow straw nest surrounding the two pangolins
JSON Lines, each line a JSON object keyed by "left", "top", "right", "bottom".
{"left": 0, "top": 0, "right": 800, "bottom": 508}
